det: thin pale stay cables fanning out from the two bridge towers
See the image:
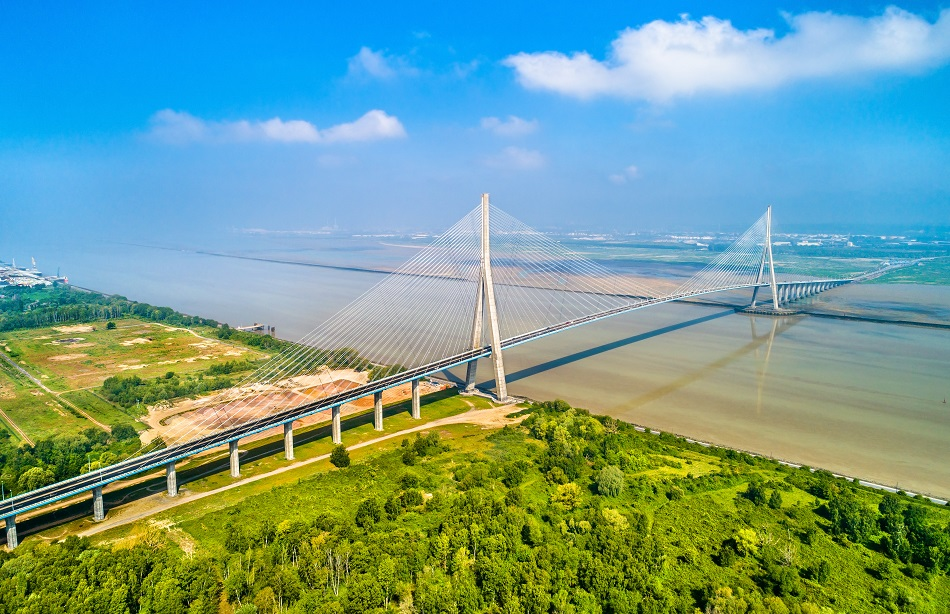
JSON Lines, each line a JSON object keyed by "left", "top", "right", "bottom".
{"left": 136, "top": 201, "right": 804, "bottom": 448}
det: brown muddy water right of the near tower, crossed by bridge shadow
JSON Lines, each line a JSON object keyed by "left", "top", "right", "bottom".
{"left": 458, "top": 298, "right": 950, "bottom": 497}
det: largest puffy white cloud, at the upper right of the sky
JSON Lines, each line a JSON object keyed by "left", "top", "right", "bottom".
{"left": 504, "top": 7, "right": 950, "bottom": 101}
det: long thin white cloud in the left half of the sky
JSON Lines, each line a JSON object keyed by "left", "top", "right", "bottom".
{"left": 149, "top": 109, "right": 406, "bottom": 144}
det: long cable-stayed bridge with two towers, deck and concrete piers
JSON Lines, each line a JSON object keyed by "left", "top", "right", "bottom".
{"left": 0, "top": 194, "right": 910, "bottom": 547}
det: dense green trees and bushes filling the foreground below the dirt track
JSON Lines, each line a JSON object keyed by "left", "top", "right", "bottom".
{"left": 0, "top": 402, "right": 950, "bottom": 614}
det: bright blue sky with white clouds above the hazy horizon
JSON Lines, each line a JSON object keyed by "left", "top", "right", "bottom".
{"left": 0, "top": 2, "right": 950, "bottom": 243}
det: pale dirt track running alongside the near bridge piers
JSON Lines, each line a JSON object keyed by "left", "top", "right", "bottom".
{"left": 77, "top": 404, "right": 524, "bottom": 537}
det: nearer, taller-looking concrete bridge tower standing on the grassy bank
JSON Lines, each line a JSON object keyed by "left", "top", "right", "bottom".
{"left": 465, "top": 194, "right": 508, "bottom": 401}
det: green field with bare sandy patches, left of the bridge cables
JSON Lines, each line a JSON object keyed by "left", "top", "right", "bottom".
{"left": 0, "top": 319, "right": 265, "bottom": 392}
